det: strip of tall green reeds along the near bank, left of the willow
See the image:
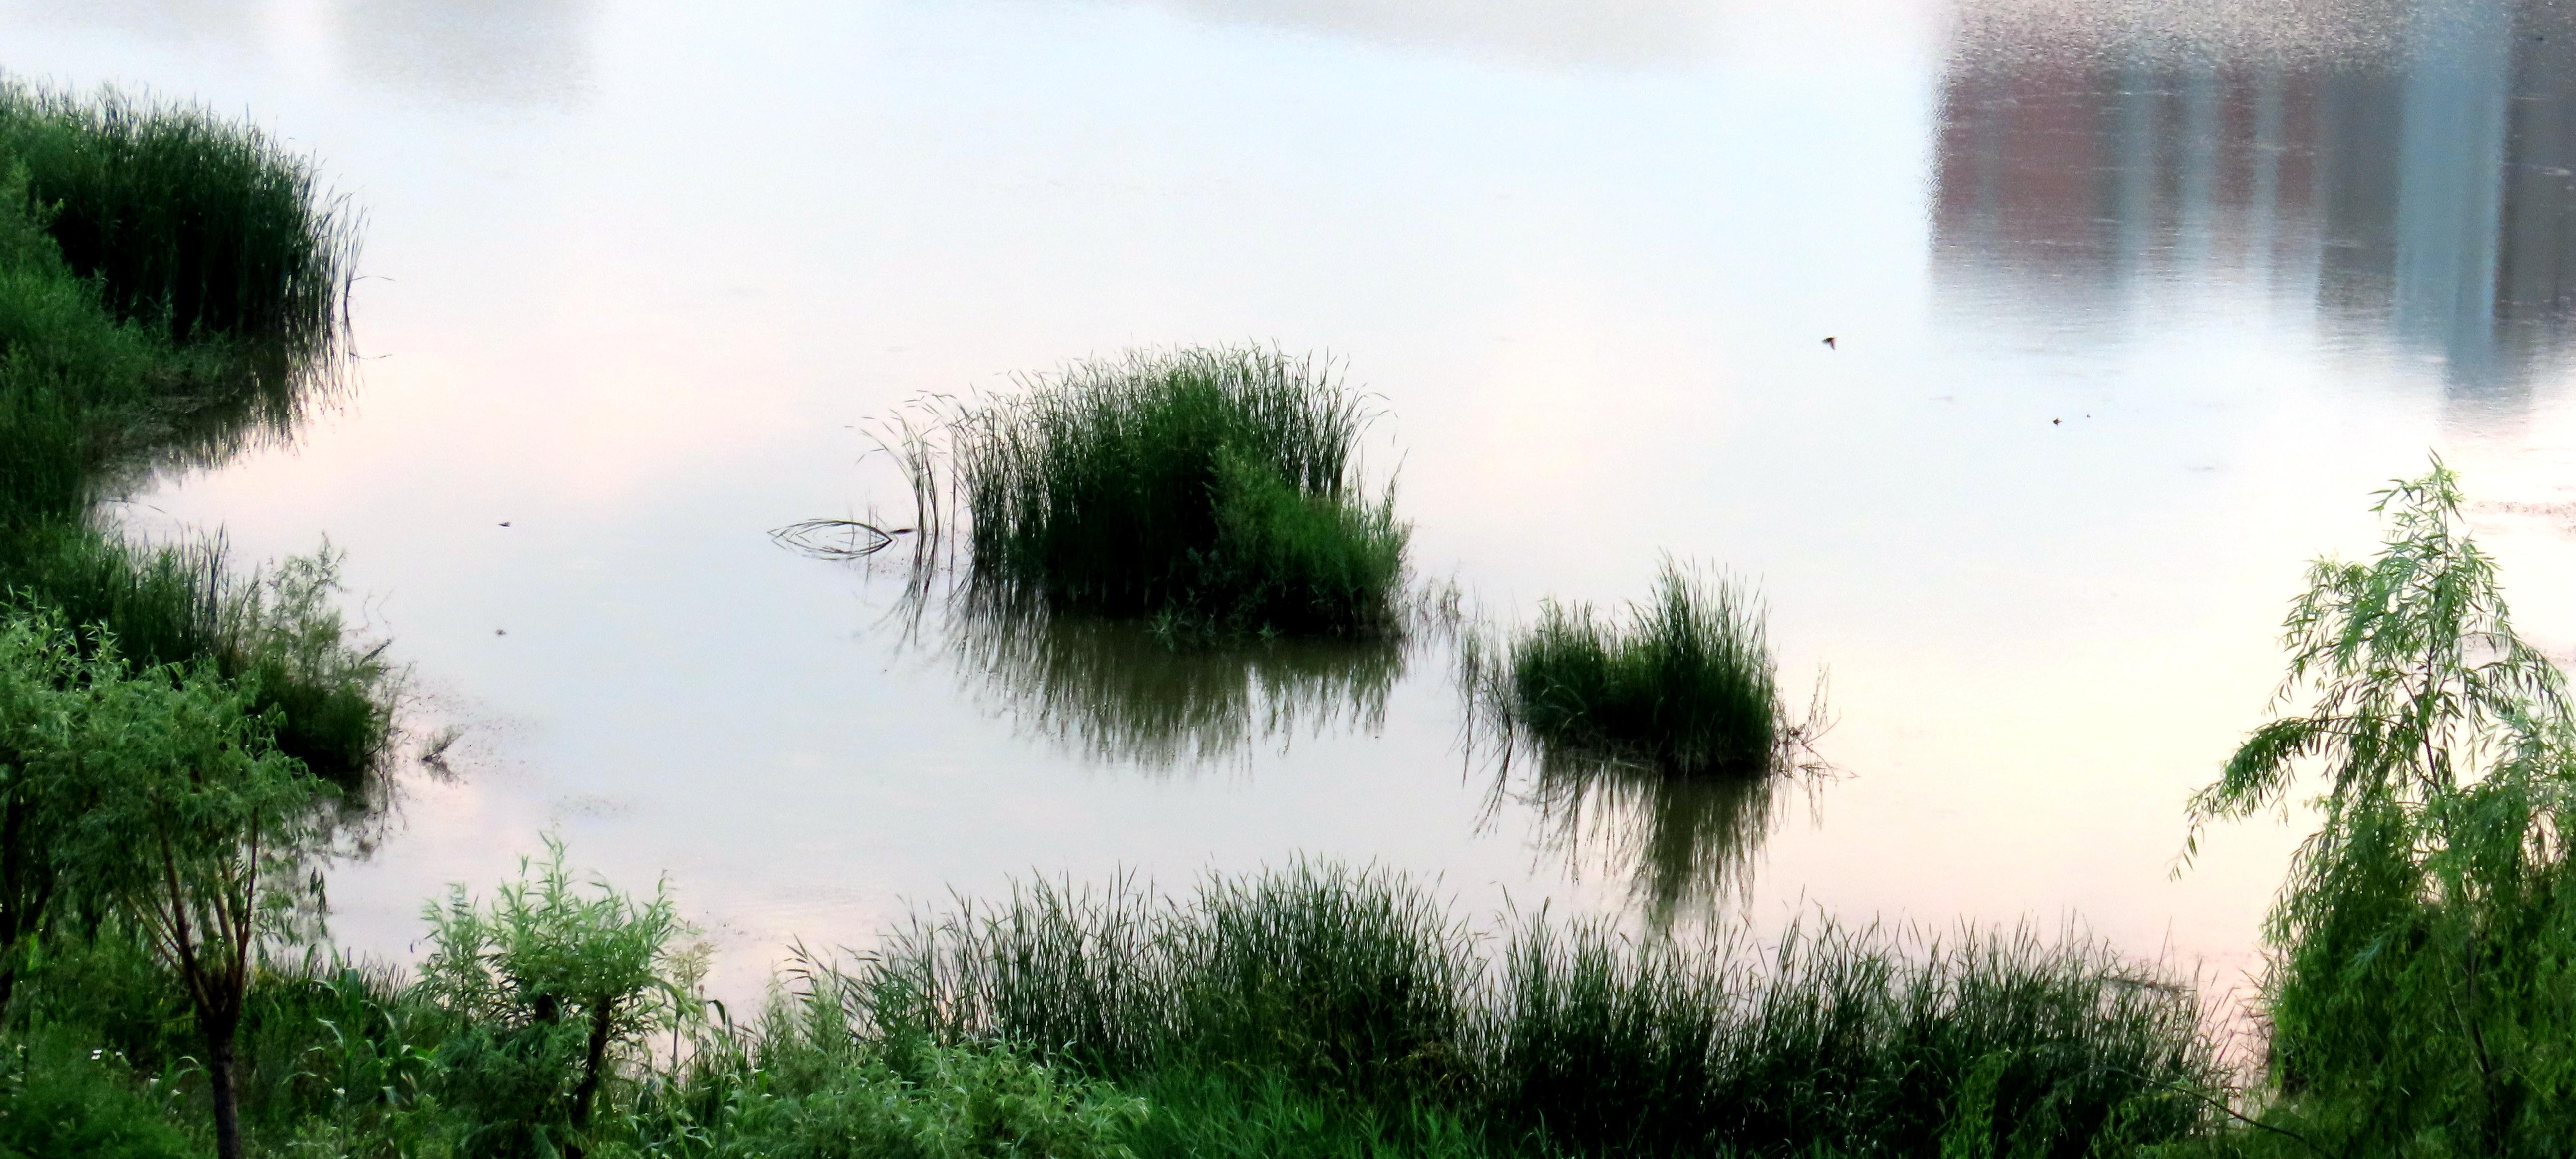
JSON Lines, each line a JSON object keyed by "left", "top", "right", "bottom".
{"left": 868, "top": 863, "right": 2221, "bottom": 1157}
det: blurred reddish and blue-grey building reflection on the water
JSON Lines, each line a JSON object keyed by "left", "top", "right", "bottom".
{"left": 1932, "top": 0, "right": 2576, "bottom": 405}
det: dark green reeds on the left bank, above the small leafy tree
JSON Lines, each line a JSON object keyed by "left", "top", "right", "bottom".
{"left": 0, "top": 85, "right": 392, "bottom": 788}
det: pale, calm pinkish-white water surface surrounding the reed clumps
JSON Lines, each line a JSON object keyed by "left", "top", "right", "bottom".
{"left": 0, "top": 0, "right": 2576, "bottom": 994}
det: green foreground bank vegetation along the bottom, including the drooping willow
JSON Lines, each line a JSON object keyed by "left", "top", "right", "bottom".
{"left": 25, "top": 464, "right": 2576, "bottom": 1159}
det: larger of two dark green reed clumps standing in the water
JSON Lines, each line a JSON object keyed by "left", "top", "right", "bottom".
{"left": 948, "top": 350, "right": 1406, "bottom": 636}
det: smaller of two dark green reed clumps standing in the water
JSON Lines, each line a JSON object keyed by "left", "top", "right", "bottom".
{"left": 1466, "top": 559, "right": 1803, "bottom": 778}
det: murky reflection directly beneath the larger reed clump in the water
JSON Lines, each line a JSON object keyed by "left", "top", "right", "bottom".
{"left": 946, "top": 600, "right": 1404, "bottom": 770}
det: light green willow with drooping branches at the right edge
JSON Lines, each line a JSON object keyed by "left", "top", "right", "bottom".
{"left": 2192, "top": 461, "right": 2576, "bottom": 1154}
